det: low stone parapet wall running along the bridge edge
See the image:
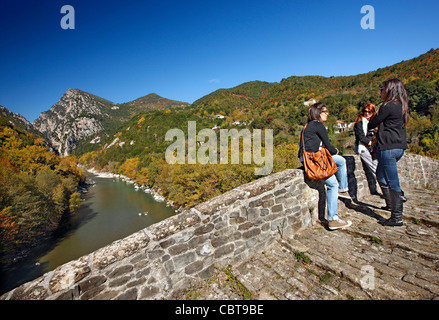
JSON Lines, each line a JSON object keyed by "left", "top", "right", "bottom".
{"left": 0, "top": 155, "right": 439, "bottom": 300}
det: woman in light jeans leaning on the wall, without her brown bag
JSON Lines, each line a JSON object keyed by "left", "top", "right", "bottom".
{"left": 299, "top": 102, "right": 352, "bottom": 230}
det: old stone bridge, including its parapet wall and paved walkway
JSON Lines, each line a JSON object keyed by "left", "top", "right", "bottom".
{"left": 0, "top": 153, "right": 439, "bottom": 300}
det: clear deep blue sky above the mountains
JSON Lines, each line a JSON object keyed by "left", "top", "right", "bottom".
{"left": 0, "top": 0, "right": 439, "bottom": 121}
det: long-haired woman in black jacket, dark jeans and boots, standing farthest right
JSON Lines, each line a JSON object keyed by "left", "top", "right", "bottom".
{"left": 368, "top": 79, "right": 409, "bottom": 226}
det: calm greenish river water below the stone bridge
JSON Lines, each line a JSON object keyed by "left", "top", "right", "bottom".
{"left": 0, "top": 175, "right": 175, "bottom": 294}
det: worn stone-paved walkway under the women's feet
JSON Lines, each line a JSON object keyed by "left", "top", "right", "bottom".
{"left": 175, "top": 189, "right": 439, "bottom": 300}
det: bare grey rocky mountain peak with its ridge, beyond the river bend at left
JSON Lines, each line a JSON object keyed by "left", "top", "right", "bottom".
{"left": 33, "top": 89, "right": 188, "bottom": 156}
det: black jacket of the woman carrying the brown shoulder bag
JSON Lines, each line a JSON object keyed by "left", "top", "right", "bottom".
{"left": 298, "top": 121, "right": 338, "bottom": 160}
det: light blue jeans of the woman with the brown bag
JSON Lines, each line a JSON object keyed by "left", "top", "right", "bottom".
{"left": 325, "top": 155, "right": 348, "bottom": 221}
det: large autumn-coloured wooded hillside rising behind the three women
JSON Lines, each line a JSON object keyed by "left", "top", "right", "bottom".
{"left": 78, "top": 49, "right": 439, "bottom": 207}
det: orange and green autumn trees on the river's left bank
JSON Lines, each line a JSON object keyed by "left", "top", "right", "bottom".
{"left": 0, "top": 117, "right": 83, "bottom": 263}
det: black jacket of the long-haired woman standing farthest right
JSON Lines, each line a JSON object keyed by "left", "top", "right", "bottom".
{"left": 368, "top": 102, "right": 408, "bottom": 150}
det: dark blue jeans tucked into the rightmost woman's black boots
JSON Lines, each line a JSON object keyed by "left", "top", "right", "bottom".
{"left": 376, "top": 148, "right": 404, "bottom": 192}
